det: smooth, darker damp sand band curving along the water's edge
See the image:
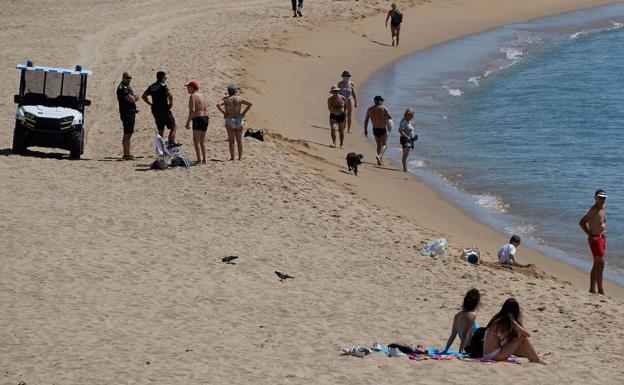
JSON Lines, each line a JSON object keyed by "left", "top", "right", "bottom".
{"left": 247, "top": 1, "right": 624, "bottom": 299}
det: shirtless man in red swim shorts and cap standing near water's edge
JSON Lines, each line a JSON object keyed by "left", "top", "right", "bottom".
{"left": 579, "top": 189, "right": 607, "bottom": 294}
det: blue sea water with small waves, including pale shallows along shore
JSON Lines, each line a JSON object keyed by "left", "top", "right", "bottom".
{"left": 359, "top": 3, "right": 624, "bottom": 284}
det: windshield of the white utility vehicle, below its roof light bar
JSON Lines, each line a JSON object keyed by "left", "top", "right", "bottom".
{"left": 24, "top": 71, "right": 81, "bottom": 98}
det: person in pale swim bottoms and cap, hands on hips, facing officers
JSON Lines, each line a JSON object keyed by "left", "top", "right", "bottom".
{"left": 217, "top": 84, "right": 252, "bottom": 160}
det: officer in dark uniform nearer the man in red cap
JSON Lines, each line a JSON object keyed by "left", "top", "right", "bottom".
{"left": 141, "top": 71, "right": 179, "bottom": 147}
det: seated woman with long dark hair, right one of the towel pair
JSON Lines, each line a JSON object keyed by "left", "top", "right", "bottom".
{"left": 483, "top": 298, "right": 546, "bottom": 365}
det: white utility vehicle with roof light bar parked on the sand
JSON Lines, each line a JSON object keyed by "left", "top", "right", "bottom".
{"left": 13, "top": 60, "right": 91, "bottom": 159}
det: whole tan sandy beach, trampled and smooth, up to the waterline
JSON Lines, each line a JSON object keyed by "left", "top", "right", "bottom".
{"left": 0, "top": 0, "right": 624, "bottom": 385}
